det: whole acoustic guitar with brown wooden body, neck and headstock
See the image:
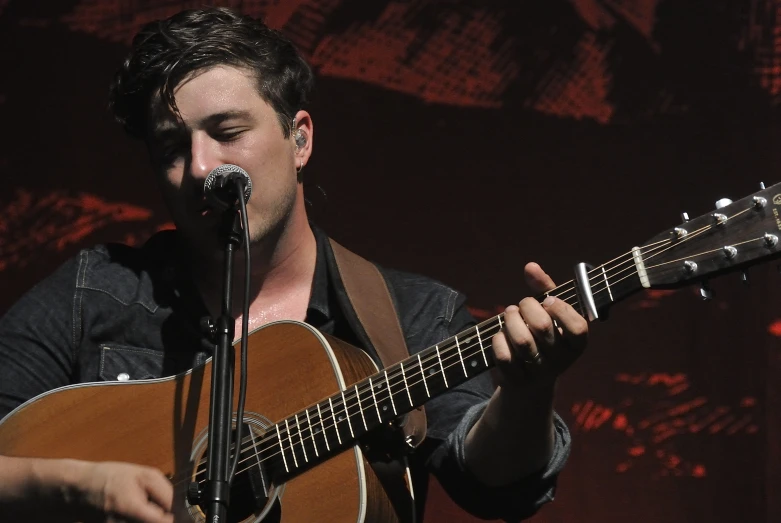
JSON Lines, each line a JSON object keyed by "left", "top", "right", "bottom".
{"left": 0, "top": 184, "right": 781, "bottom": 523}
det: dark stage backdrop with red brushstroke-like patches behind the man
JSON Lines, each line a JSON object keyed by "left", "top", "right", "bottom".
{"left": 0, "top": 0, "right": 781, "bottom": 523}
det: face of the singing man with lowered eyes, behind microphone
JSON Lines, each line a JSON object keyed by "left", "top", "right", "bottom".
{"left": 147, "top": 66, "right": 308, "bottom": 255}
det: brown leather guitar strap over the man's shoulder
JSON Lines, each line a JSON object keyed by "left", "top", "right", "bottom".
{"left": 329, "top": 238, "right": 426, "bottom": 447}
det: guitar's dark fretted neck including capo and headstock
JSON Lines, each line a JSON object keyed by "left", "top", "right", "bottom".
{"left": 272, "top": 184, "right": 781, "bottom": 478}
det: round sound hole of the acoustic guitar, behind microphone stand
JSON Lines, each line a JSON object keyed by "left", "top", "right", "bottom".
{"left": 190, "top": 419, "right": 282, "bottom": 523}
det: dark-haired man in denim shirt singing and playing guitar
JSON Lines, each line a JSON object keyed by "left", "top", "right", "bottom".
{"left": 0, "top": 9, "right": 587, "bottom": 522}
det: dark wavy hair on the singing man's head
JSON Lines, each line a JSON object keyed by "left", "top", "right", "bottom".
{"left": 109, "top": 8, "right": 314, "bottom": 139}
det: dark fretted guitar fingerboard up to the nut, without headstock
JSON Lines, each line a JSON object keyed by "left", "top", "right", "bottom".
{"left": 272, "top": 262, "right": 642, "bottom": 473}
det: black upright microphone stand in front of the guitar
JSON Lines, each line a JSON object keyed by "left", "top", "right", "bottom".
{"left": 188, "top": 208, "right": 241, "bottom": 523}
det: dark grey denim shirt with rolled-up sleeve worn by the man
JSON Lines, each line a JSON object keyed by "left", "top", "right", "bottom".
{"left": 0, "top": 228, "right": 570, "bottom": 521}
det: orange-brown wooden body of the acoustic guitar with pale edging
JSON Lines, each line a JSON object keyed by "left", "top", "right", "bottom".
{"left": 0, "top": 322, "right": 412, "bottom": 523}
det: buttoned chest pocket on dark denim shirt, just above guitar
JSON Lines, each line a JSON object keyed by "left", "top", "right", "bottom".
{"left": 99, "top": 344, "right": 163, "bottom": 381}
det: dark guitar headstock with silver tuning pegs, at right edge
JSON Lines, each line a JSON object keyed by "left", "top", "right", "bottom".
{"left": 636, "top": 184, "right": 781, "bottom": 288}
